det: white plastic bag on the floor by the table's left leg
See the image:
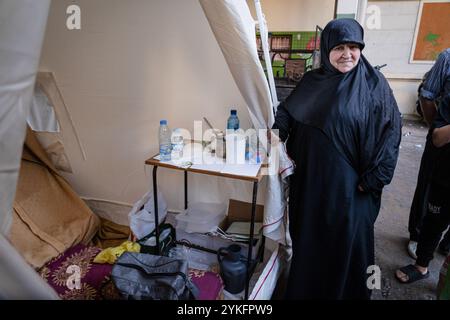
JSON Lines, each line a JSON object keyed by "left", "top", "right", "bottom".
{"left": 128, "top": 190, "right": 167, "bottom": 239}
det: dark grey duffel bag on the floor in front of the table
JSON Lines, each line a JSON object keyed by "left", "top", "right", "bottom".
{"left": 111, "top": 252, "right": 198, "bottom": 300}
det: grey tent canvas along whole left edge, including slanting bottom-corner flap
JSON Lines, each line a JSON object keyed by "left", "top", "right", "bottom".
{"left": 0, "top": 0, "right": 58, "bottom": 299}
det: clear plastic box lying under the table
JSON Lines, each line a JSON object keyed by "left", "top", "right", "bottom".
{"left": 175, "top": 202, "right": 227, "bottom": 233}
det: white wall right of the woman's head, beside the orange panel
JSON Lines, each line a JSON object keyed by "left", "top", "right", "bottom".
{"left": 364, "top": 1, "right": 432, "bottom": 114}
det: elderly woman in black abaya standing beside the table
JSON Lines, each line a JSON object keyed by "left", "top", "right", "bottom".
{"left": 273, "top": 19, "right": 401, "bottom": 299}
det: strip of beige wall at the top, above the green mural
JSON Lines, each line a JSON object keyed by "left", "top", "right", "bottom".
{"left": 247, "top": 0, "right": 334, "bottom": 31}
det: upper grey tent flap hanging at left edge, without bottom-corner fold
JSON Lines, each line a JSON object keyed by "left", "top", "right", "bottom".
{"left": 0, "top": 0, "right": 50, "bottom": 234}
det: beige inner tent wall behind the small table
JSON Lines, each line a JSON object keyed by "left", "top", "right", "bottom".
{"left": 40, "top": 0, "right": 260, "bottom": 208}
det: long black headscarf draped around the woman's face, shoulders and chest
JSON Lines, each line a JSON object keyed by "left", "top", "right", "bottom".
{"left": 285, "top": 19, "right": 401, "bottom": 190}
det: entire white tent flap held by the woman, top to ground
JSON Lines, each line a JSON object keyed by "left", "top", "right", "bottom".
{"left": 199, "top": 0, "right": 293, "bottom": 300}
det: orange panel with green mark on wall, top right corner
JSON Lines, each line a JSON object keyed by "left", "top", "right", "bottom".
{"left": 411, "top": 1, "right": 450, "bottom": 62}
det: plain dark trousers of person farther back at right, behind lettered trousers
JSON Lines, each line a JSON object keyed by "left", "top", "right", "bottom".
{"left": 408, "top": 135, "right": 450, "bottom": 250}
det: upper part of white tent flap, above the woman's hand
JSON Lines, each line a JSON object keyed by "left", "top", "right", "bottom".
{"left": 200, "top": 0, "right": 274, "bottom": 130}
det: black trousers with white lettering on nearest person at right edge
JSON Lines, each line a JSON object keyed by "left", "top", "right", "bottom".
{"left": 416, "top": 183, "right": 450, "bottom": 267}
